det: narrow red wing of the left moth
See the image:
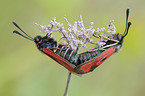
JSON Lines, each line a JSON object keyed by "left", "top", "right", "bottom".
{"left": 43, "top": 48, "right": 76, "bottom": 74}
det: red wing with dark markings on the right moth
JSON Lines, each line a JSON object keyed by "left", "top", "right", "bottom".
{"left": 75, "top": 47, "right": 116, "bottom": 74}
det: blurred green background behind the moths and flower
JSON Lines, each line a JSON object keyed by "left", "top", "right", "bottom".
{"left": 0, "top": 0, "right": 145, "bottom": 96}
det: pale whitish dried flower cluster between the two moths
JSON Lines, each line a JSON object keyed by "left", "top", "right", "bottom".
{"left": 36, "top": 15, "right": 116, "bottom": 51}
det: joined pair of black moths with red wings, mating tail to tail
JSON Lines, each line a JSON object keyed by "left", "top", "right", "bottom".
{"left": 13, "top": 9, "right": 131, "bottom": 74}
